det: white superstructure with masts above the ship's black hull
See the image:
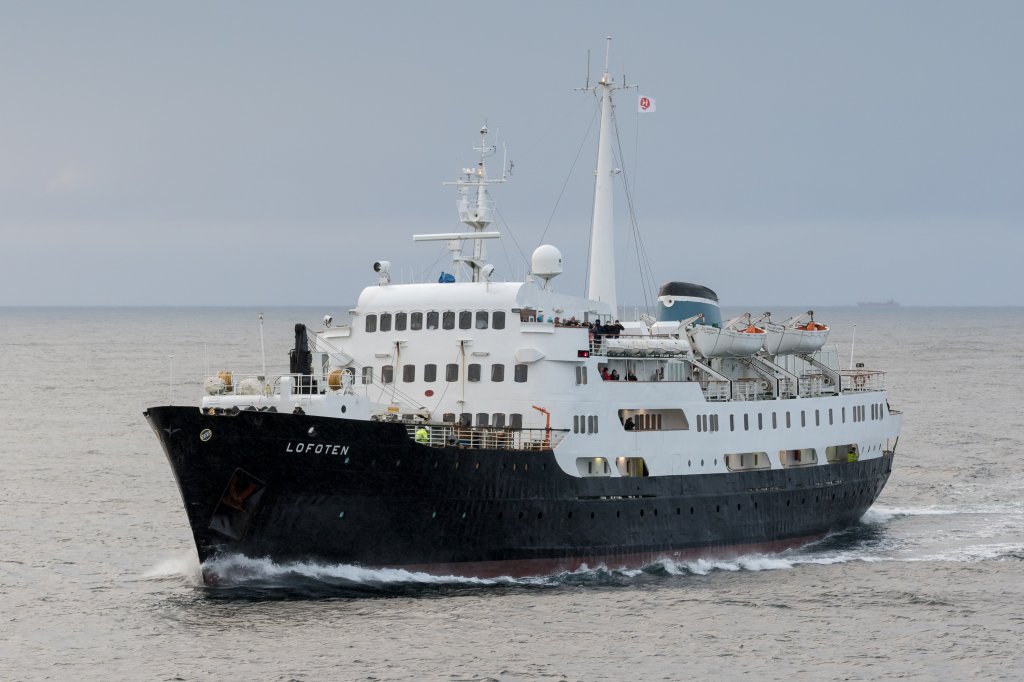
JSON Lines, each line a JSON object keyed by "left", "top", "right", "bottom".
{"left": 204, "top": 38, "right": 900, "bottom": 483}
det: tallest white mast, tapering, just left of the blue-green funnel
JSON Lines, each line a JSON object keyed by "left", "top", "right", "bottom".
{"left": 587, "top": 36, "right": 618, "bottom": 316}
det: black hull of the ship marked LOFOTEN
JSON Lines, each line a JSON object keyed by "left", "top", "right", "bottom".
{"left": 146, "top": 407, "right": 893, "bottom": 577}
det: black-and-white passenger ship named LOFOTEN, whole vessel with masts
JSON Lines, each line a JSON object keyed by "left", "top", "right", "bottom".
{"left": 144, "top": 39, "right": 901, "bottom": 583}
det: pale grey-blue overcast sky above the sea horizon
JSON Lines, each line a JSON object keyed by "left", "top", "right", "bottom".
{"left": 0, "top": 1, "right": 1024, "bottom": 306}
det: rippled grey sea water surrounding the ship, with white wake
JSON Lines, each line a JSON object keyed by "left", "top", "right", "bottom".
{"left": 0, "top": 306, "right": 1024, "bottom": 680}
